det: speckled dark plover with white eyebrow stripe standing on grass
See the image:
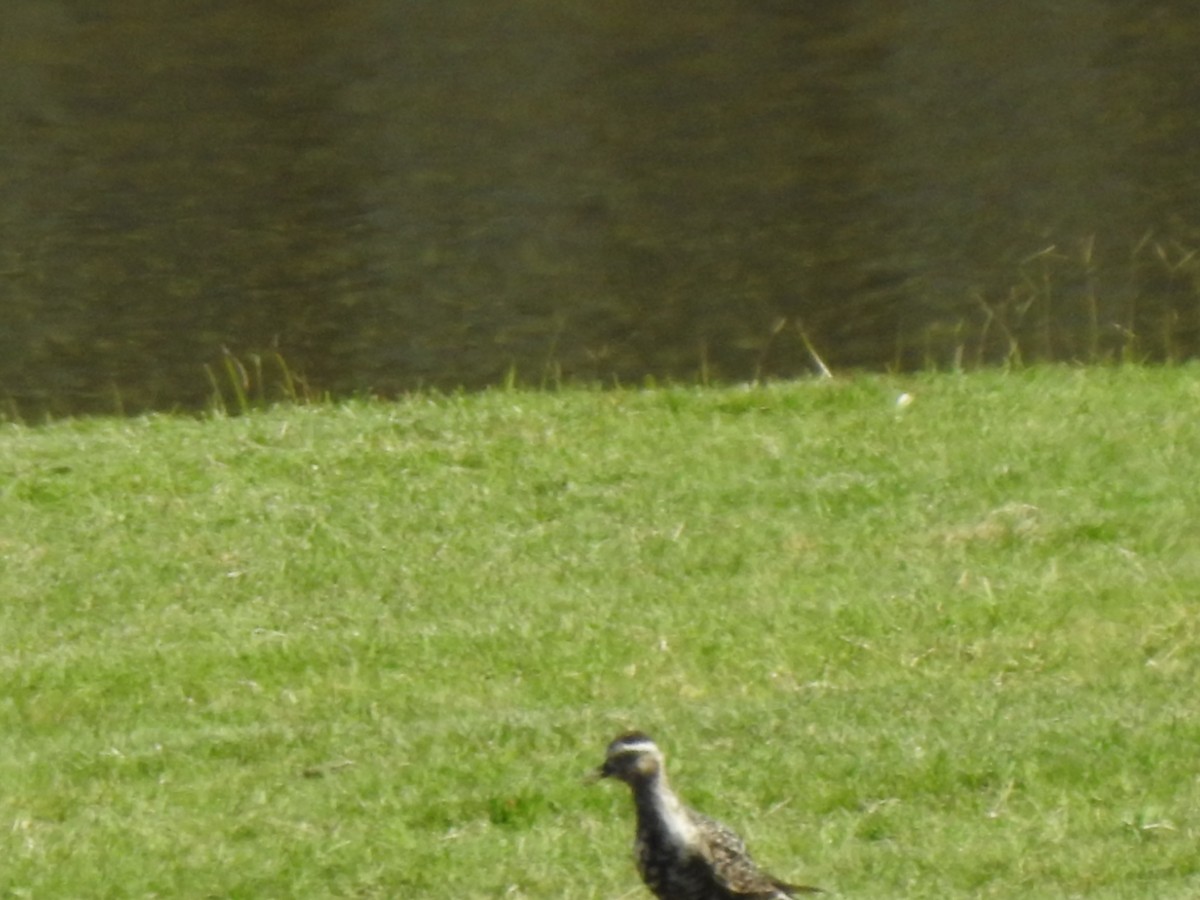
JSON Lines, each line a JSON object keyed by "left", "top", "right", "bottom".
{"left": 593, "top": 731, "right": 824, "bottom": 900}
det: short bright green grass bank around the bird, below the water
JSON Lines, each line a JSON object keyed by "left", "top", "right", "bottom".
{"left": 0, "top": 366, "right": 1200, "bottom": 900}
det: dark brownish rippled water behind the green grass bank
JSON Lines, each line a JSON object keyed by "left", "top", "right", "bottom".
{"left": 0, "top": 0, "right": 1200, "bottom": 416}
